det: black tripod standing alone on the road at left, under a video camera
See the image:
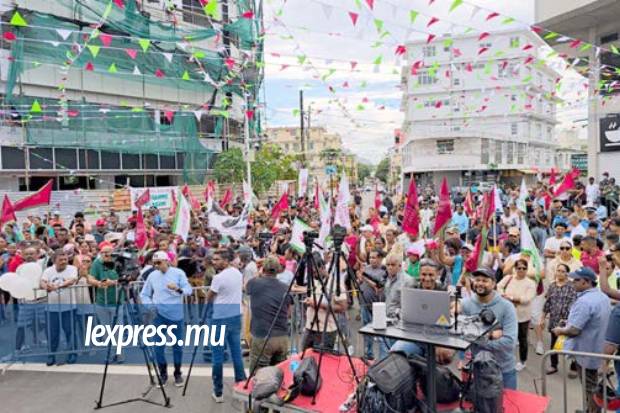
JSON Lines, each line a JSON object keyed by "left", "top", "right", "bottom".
{"left": 95, "top": 280, "right": 171, "bottom": 409}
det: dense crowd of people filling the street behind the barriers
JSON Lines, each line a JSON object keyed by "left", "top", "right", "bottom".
{"left": 0, "top": 171, "right": 620, "bottom": 411}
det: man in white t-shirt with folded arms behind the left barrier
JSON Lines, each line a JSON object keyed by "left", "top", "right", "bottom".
{"left": 40, "top": 250, "right": 78, "bottom": 366}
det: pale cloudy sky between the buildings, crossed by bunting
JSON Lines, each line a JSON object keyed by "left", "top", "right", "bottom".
{"left": 263, "top": 0, "right": 581, "bottom": 164}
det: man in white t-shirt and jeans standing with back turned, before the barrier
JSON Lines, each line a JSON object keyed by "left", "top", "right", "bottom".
{"left": 207, "top": 249, "right": 246, "bottom": 403}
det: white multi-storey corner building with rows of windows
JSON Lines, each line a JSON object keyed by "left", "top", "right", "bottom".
{"left": 401, "top": 31, "right": 558, "bottom": 187}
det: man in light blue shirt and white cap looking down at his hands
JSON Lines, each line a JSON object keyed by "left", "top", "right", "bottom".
{"left": 140, "top": 251, "right": 192, "bottom": 387}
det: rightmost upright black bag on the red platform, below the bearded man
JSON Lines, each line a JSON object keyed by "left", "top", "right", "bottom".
{"left": 467, "top": 351, "right": 504, "bottom": 413}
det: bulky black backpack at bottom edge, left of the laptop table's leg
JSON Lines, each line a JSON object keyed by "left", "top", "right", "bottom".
{"left": 358, "top": 353, "right": 417, "bottom": 413}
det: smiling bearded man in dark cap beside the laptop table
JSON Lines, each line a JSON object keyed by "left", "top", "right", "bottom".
{"left": 461, "top": 267, "right": 518, "bottom": 389}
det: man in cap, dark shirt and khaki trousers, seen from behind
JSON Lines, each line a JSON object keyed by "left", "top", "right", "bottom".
{"left": 245, "top": 256, "right": 293, "bottom": 371}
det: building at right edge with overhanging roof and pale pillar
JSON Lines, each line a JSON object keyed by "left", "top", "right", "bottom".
{"left": 535, "top": 0, "right": 620, "bottom": 178}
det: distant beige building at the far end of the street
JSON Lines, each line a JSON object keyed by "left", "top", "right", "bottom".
{"left": 266, "top": 127, "right": 358, "bottom": 183}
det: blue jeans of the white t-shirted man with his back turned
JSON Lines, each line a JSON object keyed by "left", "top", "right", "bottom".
{"left": 211, "top": 315, "right": 246, "bottom": 396}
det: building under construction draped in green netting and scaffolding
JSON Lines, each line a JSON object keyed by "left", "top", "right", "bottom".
{"left": 0, "top": 0, "right": 262, "bottom": 191}
